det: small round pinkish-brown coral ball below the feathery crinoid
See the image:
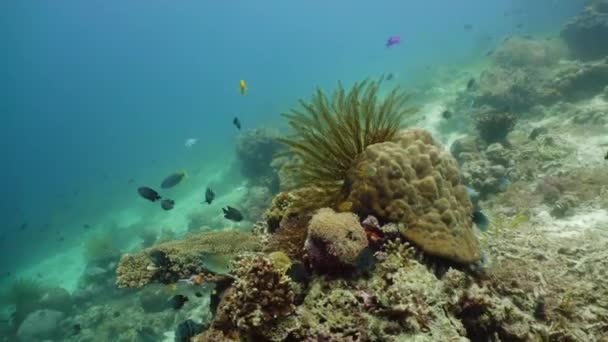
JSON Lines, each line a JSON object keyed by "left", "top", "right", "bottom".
{"left": 305, "top": 208, "right": 368, "bottom": 269}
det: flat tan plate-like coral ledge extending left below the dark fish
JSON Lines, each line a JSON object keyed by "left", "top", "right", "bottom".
{"left": 117, "top": 231, "right": 262, "bottom": 287}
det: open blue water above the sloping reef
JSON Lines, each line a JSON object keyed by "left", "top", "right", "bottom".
{"left": 0, "top": 0, "right": 583, "bottom": 273}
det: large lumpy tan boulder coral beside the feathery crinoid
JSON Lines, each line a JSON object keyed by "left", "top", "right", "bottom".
{"left": 345, "top": 129, "right": 481, "bottom": 263}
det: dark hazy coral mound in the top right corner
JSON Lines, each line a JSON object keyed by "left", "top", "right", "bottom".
{"left": 561, "top": 1, "right": 608, "bottom": 60}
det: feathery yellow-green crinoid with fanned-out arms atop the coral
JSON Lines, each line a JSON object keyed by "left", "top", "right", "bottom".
{"left": 279, "top": 81, "right": 414, "bottom": 204}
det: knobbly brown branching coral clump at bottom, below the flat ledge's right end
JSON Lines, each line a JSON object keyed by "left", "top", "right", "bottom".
{"left": 213, "top": 254, "right": 296, "bottom": 341}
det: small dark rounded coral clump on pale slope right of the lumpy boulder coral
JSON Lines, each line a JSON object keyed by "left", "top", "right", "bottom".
{"left": 475, "top": 106, "right": 517, "bottom": 144}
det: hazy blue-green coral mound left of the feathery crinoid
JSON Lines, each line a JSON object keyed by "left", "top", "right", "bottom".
{"left": 236, "top": 128, "right": 281, "bottom": 192}
